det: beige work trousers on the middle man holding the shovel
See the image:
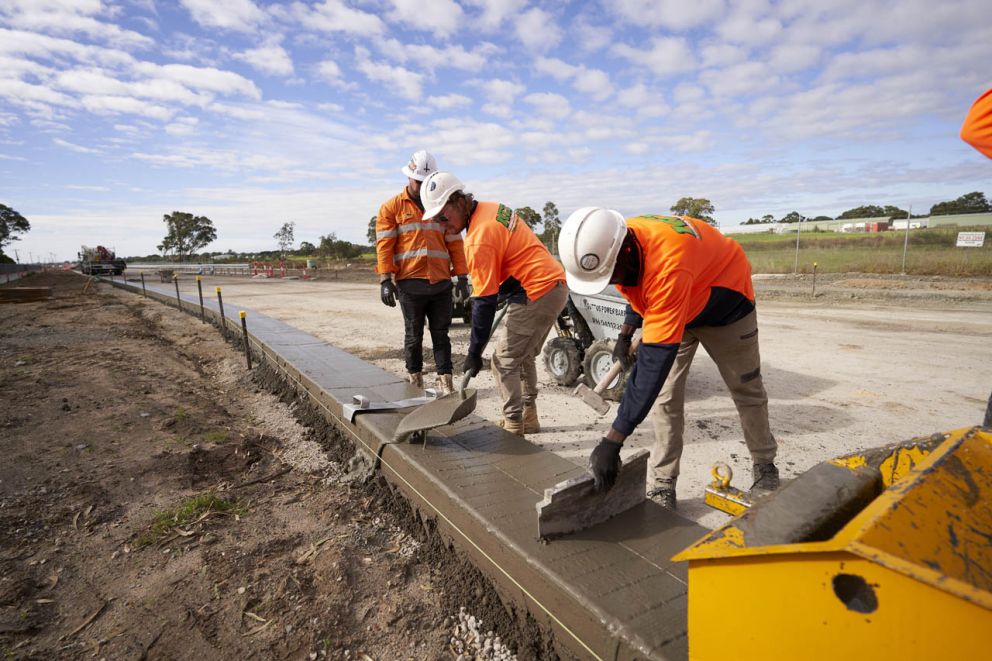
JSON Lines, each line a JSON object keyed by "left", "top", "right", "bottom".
{"left": 492, "top": 282, "right": 568, "bottom": 420}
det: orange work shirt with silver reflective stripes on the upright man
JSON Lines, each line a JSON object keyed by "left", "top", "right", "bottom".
{"left": 375, "top": 187, "right": 468, "bottom": 284}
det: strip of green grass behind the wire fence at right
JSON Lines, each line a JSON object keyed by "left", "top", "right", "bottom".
{"left": 732, "top": 227, "right": 992, "bottom": 277}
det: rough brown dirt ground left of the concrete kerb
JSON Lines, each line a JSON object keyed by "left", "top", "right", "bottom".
{"left": 0, "top": 273, "right": 534, "bottom": 659}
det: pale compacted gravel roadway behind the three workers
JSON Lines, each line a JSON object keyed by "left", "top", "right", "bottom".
{"left": 180, "top": 274, "right": 992, "bottom": 527}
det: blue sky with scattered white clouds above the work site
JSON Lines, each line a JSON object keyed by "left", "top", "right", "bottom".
{"left": 0, "top": 0, "right": 992, "bottom": 262}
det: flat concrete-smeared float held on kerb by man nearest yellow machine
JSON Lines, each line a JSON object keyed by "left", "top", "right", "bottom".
{"left": 537, "top": 450, "right": 651, "bottom": 539}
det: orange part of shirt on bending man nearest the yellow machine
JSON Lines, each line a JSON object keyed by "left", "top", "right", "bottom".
{"left": 617, "top": 215, "right": 754, "bottom": 344}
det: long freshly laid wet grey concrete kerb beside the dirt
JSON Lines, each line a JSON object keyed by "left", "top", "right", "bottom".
{"left": 113, "top": 274, "right": 708, "bottom": 659}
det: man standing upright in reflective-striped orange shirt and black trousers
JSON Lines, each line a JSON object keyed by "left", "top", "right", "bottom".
{"left": 375, "top": 150, "right": 468, "bottom": 394}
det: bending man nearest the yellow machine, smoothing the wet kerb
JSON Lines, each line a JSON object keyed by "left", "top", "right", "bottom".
{"left": 558, "top": 207, "right": 779, "bottom": 509}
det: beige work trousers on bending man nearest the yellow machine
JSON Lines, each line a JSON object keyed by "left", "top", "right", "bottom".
{"left": 651, "top": 311, "right": 778, "bottom": 481}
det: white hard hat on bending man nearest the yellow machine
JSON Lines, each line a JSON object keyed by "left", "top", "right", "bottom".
{"left": 558, "top": 207, "right": 627, "bottom": 295}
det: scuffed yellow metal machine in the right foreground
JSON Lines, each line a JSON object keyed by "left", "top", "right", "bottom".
{"left": 674, "top": 427, "right": 992, "bottom": 661}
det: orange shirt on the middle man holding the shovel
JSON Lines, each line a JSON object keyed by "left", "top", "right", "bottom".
{"left": 465, "top": 202, "right": 565, "bottom": 301}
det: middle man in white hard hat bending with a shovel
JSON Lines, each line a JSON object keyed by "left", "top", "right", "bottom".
{"left": 420, "top": 172, "right": 568, "bottom": 436}
